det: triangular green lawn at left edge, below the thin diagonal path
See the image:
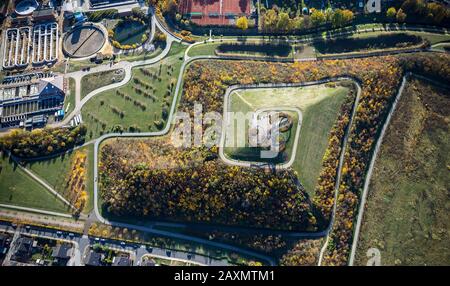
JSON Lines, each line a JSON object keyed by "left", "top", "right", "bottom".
{"left": 0, "top": 156, "right": 68, "bottom": 213}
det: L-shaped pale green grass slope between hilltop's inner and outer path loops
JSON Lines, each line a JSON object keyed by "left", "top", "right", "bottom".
{"left": 224, "top": 85, "right": 349, "bottom": 194}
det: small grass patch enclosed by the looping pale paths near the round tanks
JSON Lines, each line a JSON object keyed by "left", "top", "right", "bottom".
{"left": 81, "top": 69, "right": 125, "bottom": 99}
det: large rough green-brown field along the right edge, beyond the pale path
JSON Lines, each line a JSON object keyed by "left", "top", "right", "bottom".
{"left": 355, "top": 79, "right": 450, "bottom": 265}
